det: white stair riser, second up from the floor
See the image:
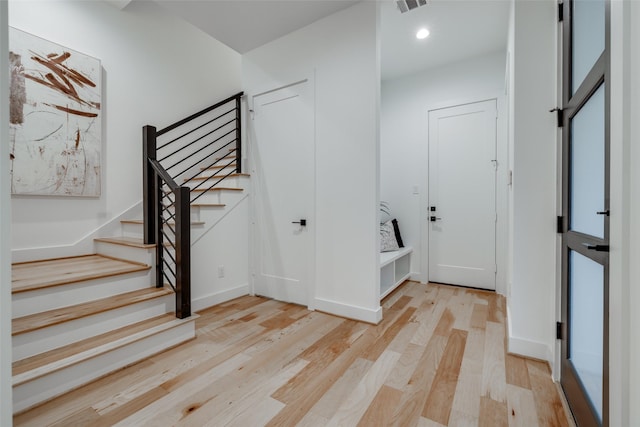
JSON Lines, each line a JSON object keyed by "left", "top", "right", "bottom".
{"left": 12, "top": 294, "right": 175, "bottom": 361}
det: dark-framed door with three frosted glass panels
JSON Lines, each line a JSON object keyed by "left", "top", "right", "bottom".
{"left": 561, "top": 0, "right": 609, "bottom": 426}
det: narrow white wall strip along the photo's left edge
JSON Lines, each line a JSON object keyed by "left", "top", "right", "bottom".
{"left": 0, "top": 1, "right": 12, "bottom": 426}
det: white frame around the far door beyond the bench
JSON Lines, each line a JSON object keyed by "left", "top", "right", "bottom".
{"left": 417, "top": 92, "right": 511, "bottom": 296}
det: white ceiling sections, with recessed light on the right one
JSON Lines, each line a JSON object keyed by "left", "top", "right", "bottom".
{"left": 149, "top": 0, "right": 510, "bottom": 80}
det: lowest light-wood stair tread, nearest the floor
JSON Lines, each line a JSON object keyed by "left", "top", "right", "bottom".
{"left": 12, "top": 313, "right": 188, "bottom": 386}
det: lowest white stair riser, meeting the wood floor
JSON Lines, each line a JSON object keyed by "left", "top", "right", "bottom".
{"left": 13, "top": 321, "right": 195, "bottom": 413}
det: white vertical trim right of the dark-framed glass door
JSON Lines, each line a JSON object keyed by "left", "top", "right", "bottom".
{"left": 608, "top": 1, "right": 639, "bottom": 426}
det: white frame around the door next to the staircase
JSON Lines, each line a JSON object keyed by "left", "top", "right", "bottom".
{"left": 244, "top": 72, "right": 316, "bottom": 310}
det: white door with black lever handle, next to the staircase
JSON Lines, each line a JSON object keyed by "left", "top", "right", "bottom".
{"left": 252, "top": 80, "right": 314, "bottom": 305}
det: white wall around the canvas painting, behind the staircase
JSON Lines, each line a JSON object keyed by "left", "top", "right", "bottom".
{"left": 9, "top": 0, "right": 241, "bottom": 260}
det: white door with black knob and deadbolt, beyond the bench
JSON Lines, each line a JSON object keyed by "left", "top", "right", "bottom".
{"left": 427, "top": 100, "right": 497, "bottom": 290}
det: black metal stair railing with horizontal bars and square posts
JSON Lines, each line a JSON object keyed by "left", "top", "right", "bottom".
{"left": 142, "top": 92, "right": 242, "bottom": 319}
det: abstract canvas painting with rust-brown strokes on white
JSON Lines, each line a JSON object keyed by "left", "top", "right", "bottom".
{"left": 9, "top": 28, "right": 102, "bottom": 197}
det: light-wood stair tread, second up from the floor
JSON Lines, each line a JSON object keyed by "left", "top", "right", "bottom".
{"left": 11, "top": 288, "right": 173, "bottom": 336}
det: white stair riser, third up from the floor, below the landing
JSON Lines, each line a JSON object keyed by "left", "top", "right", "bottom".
{"left": 12, "top": 269, "right": 153, "bottom": 319}
